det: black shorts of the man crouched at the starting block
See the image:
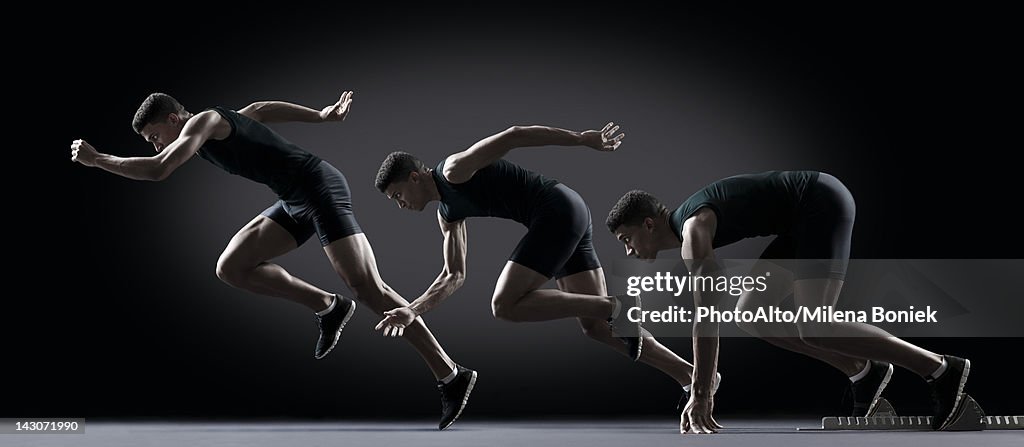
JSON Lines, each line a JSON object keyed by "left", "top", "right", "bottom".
{"left": 761, "top": 173, "right": 857, "bottom": 279}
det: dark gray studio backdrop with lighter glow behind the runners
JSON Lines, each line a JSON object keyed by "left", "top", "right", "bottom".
{"left": 24, "top": 3, "right": 1022, "bottom": 418}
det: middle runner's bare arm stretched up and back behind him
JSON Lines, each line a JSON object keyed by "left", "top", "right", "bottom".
{"left": 441, "top": 123, "right": 626, "bottom": 183}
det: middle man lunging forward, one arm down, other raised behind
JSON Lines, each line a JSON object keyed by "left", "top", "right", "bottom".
{"left": 376, "top": 123, "right": 717, "bottom": 411}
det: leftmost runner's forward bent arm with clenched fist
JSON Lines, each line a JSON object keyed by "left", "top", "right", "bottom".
{"left": 71, "top": 110, "right": 230, "bottom": 181}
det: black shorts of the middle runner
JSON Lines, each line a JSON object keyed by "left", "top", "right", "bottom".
{"left": 509, "top": 183, "right": 601, "bottom": 279}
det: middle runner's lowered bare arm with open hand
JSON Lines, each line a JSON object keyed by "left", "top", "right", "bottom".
{"left": 375, "top": 213, "right": 467, "bottom": 336}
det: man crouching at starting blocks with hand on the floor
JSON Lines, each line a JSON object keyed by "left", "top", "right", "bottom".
{"left": 605, "top": 171, "right": 971, "bottom": 433}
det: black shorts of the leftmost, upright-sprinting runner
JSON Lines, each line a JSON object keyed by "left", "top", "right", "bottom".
{"left": 261, "top": 161, "right": 362, "bottom": 245}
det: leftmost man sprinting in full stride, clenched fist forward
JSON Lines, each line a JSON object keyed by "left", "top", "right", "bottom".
{"left": 71, "top": 91, "right": 476, "bottom": 430}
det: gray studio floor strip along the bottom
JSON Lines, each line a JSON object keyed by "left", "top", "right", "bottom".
{"left": 0, "top": 419, "right": 1024, "bottom": 447}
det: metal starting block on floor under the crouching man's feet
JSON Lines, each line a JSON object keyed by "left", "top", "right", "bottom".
{"left": 799, "top": 394, "right": 1024, "bottom": 432}
